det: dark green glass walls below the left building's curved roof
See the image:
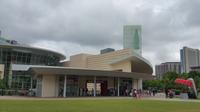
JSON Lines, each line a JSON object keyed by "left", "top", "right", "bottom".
{"left": 0, "top": 45, "right": 61, "bottom": 89}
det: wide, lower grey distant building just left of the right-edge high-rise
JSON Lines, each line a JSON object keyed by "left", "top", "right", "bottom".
{"left": 155, "top": 62, "right": 181, "bottom": 79}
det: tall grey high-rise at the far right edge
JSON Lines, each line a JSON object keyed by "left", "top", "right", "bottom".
{"left": 180, "top": 47, "right": 200, "bottom": 73}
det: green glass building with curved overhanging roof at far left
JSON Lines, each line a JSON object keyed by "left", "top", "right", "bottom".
{"left": 0, "top": 37, "right": 65, "bottom": 90}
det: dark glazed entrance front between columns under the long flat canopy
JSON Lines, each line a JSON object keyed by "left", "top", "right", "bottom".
{"left": 58, "top": 75, "right": 133, "bottom": 97}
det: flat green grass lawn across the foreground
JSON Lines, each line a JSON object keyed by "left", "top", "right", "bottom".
{"left": 0, "top": 99, "right": 200, "bottom": 112}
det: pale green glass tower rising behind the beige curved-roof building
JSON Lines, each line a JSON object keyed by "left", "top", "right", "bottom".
{"left": 123, "top": 25, "right": 142, "bottom": 55}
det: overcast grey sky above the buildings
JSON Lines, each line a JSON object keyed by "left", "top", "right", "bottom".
{"left": 0, "top": 0, "right": 200, "bottom": 73}
